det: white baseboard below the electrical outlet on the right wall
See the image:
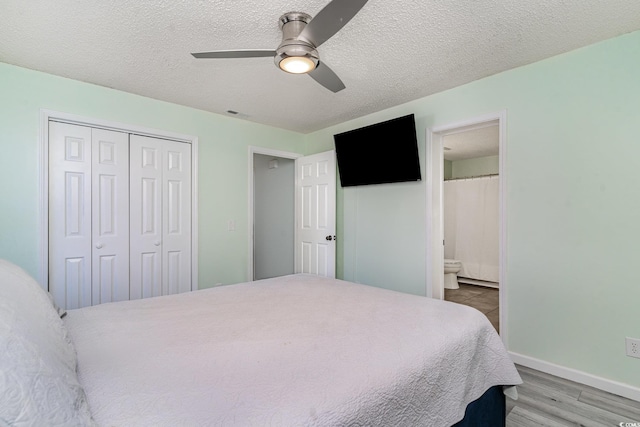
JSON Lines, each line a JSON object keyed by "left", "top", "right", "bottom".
{"left": 509, "top": 351, "right": 640, "bottom": 402}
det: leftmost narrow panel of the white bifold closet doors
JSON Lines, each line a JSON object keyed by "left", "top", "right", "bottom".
{"left": 49, "top": 122, "right": 92, "bottom": 309}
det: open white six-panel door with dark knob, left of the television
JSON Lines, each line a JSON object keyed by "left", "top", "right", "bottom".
{"left": 295, "top": 150, "right": 336, "bottom": 277}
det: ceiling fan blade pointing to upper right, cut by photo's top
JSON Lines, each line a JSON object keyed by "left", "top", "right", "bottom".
{"left": 298, "top": 0, "right": 367, "bottom": 47}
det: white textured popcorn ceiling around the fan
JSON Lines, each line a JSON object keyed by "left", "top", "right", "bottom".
{"left": 0, "top": 0, "right": 640, "bottom": 133}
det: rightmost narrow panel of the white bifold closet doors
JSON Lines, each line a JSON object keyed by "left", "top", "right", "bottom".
{"left": 162, "top": 141, "right": 191, "bottom": 295}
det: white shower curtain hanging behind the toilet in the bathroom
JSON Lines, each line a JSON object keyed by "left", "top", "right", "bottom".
{"left": 443, "top": 176, "right": 499, "bottom": 282}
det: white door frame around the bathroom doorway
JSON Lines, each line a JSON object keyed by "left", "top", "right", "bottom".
{"left": 425, "top": 110, "right": 508, "bottom": 345}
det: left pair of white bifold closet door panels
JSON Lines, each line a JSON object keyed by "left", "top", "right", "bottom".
{"left": 49, "top": 122, "right": 129, "bottom": 309}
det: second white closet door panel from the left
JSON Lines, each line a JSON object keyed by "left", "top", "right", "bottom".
{"left": 91, "top": 129, "right": 129, "bottom": 305}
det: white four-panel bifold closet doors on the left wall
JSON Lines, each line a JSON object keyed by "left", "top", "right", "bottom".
{"left": 48, "top": 121, "right": 192, "bottom": 309}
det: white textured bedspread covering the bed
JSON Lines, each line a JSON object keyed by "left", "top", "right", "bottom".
{"left": 65, "top": 275, "right": 521, "bottom": 426}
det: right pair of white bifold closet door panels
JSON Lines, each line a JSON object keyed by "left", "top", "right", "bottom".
{"left": 130, "top": 135, "right": 191, "bottom": 299}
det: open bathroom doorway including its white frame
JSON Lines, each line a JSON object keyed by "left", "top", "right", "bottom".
{"left": 427, "top": 113, "right": 506, "bottom": 339}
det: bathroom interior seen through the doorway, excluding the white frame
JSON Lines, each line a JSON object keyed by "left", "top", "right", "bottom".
{"left": 442, "top": 120, "right": 500, "bottom": 332}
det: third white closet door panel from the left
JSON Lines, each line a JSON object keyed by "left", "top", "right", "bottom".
{"left": 129, "top": 135, "right": 163, "bottom": 299}
